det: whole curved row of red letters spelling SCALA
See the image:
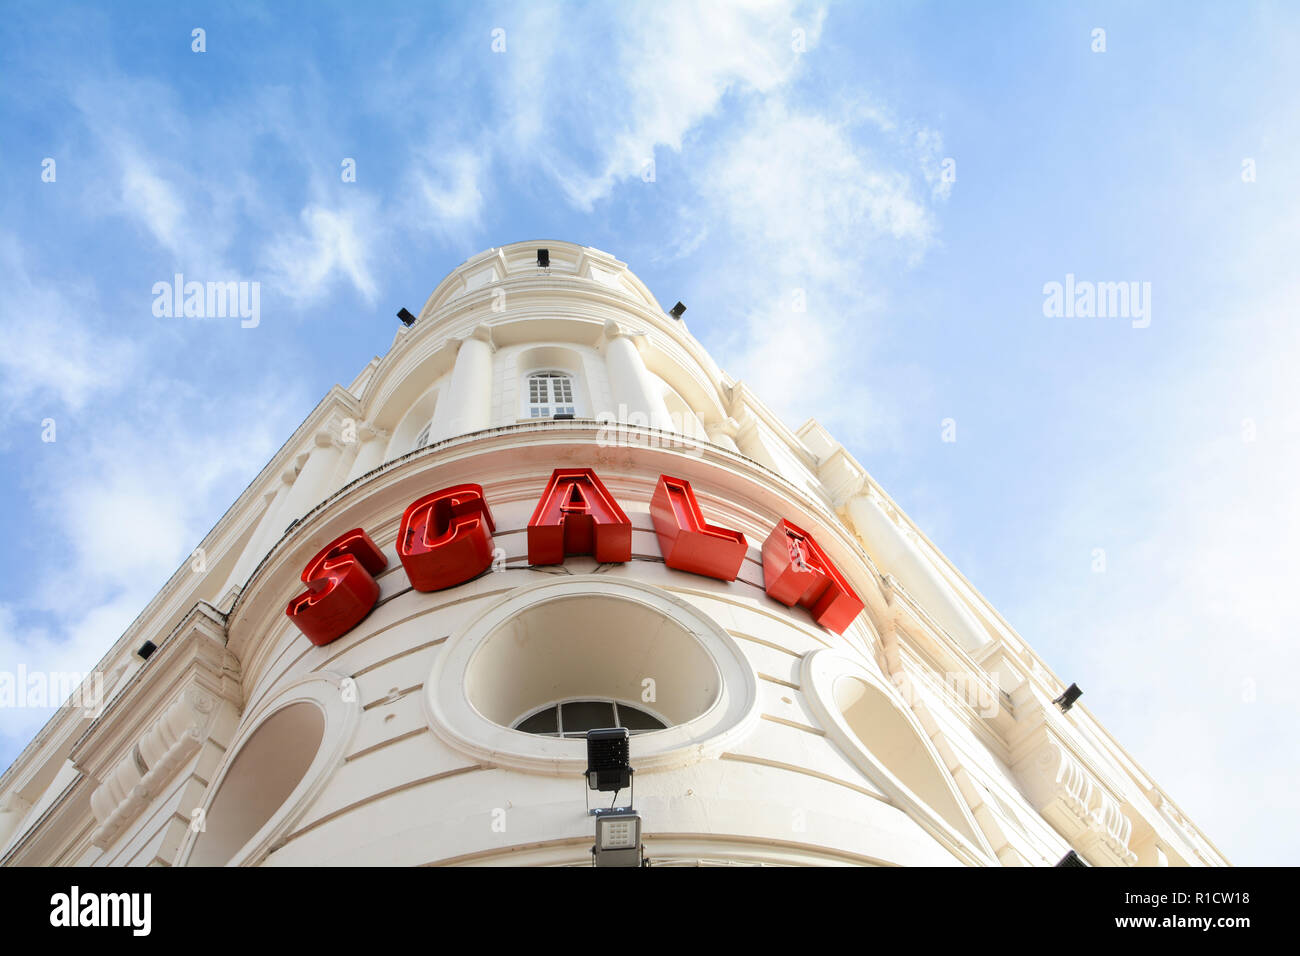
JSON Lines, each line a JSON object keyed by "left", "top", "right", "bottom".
{"left": 285, "top": 468, "right": 862, "bottom": 645}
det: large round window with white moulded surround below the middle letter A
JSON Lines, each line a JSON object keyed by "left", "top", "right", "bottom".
{"left": 424, "top": 575, "right": 758, "bottom": 773}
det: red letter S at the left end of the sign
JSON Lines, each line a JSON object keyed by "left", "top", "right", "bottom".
{"left": 285, "top": 528, "right": 389, "bottom": 646}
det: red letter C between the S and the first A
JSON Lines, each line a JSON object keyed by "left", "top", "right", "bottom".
{"left": 398, "top": 485, "right": 497, "bottom": 591}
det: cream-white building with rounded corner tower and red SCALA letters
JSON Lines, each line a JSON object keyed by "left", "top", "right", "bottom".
{"left": 0, "top": 242, "right": 1226, "bottom": 866}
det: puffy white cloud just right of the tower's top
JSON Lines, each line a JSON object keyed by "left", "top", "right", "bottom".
{"left": 694, "top": 95, "right": 936, "bottom": 444}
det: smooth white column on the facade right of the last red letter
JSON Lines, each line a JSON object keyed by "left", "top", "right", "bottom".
{"left": 849, "top": 492, "right": 992, "bottom": 652}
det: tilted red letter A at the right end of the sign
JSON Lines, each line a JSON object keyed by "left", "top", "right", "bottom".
{"left": 763, "top": 522, "right": 862, "bottom": 633}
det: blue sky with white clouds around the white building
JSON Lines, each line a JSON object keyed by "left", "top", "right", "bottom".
{"left": 0, "top": 0, "right": 1300, "bottom": 865}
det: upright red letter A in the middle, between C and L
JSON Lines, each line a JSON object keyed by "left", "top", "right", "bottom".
{"left": 528, "top": 468, "right": 632, "bottom": 564}
